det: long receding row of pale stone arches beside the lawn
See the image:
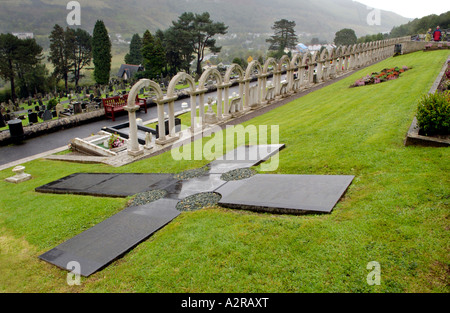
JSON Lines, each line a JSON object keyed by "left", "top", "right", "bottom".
{"left": 128, "top": 38, "right": 410, "bottom": 145}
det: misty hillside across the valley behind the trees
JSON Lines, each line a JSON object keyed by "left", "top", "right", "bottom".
{"left": 0, "top": 0, "right": 409, "bottom": 39}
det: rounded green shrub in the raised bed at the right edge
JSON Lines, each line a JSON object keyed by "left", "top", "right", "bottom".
{"left": 417, "top": 91, "right": 450, "bottom": 136}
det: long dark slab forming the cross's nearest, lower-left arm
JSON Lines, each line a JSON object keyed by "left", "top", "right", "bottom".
{"left": 39, "top": 199, "right": 180, "bottom": 277}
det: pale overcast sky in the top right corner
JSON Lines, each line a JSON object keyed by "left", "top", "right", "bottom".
{"left": 357, "top": 0, "right": 450, "bottom": 18}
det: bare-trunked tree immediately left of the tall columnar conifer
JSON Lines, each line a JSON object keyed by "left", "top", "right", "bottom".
{"left": 70, "top": 28, "right": 92, "bottom": 87}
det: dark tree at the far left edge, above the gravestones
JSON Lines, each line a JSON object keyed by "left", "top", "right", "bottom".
{"left": 0, "top": 34, "right": 42, "bottom": 103}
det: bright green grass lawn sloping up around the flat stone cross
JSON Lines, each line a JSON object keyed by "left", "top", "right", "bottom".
{"left": 0, "top": 51, "right": 450, "bottom": 293}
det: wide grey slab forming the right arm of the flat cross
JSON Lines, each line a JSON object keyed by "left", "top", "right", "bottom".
{"left": 215, "top": 175, "right": 354, "bottom": 214}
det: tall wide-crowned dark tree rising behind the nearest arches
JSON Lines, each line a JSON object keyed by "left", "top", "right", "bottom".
{"left": 171, "top": 12, "right": 228, "bottom": 75}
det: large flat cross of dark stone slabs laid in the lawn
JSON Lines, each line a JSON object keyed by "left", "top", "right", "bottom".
{"left": 36, "top": 145, "right": 354, "bottom": 276}
